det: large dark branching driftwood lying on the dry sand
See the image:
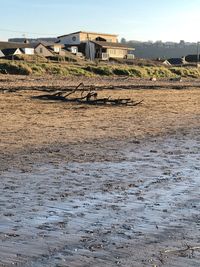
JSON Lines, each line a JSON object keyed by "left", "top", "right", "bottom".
{"left": 32, "top": 83, "right": 143, "bottom": 106}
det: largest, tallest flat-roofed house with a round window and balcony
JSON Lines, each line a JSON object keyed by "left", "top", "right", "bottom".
{"left": 58, "top": 31, "right": 134, "bottom": 60}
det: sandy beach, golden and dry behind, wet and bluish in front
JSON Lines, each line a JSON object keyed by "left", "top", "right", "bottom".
{"left": 0, "top": 76, "right": 200, "bottom": 267}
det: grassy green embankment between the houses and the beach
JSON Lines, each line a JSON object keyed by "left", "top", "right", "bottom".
{"left": 0, "top": 59, "right": 200, "bottom": 78}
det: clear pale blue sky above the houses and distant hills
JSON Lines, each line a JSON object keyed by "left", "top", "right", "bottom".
{"left": 0, "top": 0, "right": 200, "bottom": 42}
